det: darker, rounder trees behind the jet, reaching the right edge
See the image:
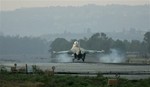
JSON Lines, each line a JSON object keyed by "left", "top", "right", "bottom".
{"left": 50, "top": 32, "right": 150, "bottom": 54}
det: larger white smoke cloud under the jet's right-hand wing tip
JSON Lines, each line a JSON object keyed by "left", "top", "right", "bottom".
{"left": 99, "top": 49, "right": 125, "bottom": 63}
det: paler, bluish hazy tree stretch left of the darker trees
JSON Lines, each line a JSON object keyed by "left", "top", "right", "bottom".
{"left": 0, "top": 36, "right": 48, "bottom": 55}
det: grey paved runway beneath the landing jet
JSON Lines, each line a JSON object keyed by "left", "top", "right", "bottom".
{"left": 1, "top": 63, "right": 150, "bottom": 79}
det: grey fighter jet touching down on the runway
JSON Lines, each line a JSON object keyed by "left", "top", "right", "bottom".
{"left": 53, "top": 41, "right": 104, "bottom": 62}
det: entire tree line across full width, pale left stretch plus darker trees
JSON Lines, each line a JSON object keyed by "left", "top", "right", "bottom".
{"left": 0, "top": 32, "right": 150, "bottom": 55}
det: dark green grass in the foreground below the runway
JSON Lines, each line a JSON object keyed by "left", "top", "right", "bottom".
{"left": 0, "top": 73, "right": 150, "bottom": 87}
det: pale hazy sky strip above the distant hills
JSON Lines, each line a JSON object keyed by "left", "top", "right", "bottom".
{"left": 0, "top": 0, "right": 150, "bottom": 10}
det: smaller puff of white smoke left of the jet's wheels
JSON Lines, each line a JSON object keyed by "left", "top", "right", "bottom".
{"left": 56, "top": 54, "right": 72, "bottom": 62}
